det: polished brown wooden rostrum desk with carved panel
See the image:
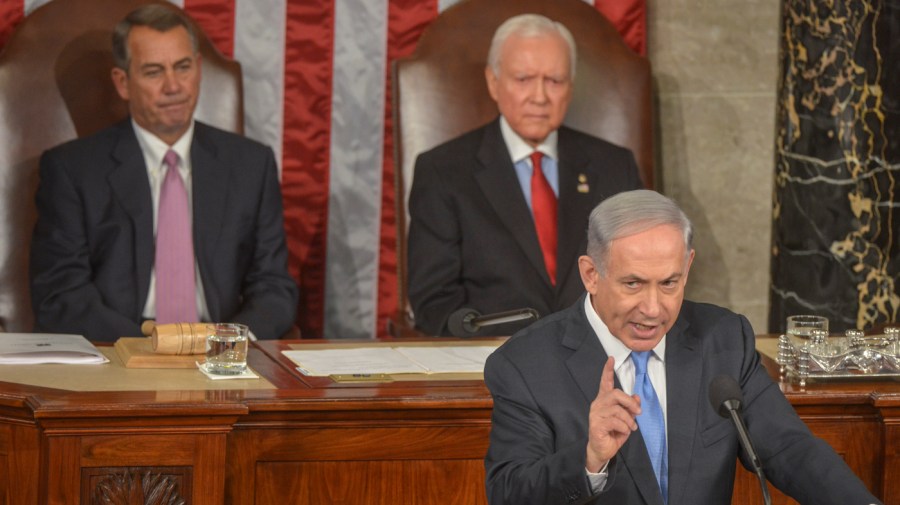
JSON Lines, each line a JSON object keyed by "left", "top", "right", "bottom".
{"left": 0, "top": 334, "right": 900, "bottom": 505}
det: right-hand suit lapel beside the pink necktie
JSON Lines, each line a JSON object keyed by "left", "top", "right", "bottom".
{"left": 191, "top": 122, "right": 234, "bottom": 319}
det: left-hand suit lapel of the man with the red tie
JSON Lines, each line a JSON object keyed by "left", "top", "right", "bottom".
{"left": 474, "top": 118, "right": 550, "bottom": 287}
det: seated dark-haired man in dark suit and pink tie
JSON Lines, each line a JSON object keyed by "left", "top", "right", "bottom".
{"left": 31, "top": 5, "right": 298, "bottom": 341}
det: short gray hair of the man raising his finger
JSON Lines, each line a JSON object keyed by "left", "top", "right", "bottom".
{"left": 587, "top": 189, "right": 694, "bottom": 276}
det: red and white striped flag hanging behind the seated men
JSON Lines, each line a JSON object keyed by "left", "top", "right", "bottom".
{"left": 0, "top": 0, "right": 646, "bottom": 338}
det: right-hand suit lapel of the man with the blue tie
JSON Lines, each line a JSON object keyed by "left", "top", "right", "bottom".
{"left": 666, "top": 318, "right": 703, "bottom": 505}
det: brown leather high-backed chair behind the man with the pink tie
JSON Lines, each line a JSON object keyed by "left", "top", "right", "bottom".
{"left": 0, "top": 0, "right": 244, "bottom": 332}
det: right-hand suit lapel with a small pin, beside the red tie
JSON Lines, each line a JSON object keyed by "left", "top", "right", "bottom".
{"left": 556, "top": 127, "right": 600, "bottom": 296}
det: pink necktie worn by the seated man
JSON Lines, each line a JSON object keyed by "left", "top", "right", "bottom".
{"left": 156, "top": 149, "right": 197, "bottom": 324}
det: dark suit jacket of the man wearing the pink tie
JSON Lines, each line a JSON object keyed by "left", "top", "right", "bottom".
{"left": 31, "top": 120, "right": 298, "bottom": 341}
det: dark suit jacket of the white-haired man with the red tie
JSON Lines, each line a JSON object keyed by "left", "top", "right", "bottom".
{"left": 407, "top": 118, "right": 643, "bottom": 335}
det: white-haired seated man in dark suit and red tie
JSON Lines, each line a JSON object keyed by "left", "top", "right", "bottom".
{"left": 407, "top": 14, "right": 642, "bottom": 335}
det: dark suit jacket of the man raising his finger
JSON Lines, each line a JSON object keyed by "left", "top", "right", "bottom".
{"left": 484, "top": 299, "right": 878, "bottom": 505}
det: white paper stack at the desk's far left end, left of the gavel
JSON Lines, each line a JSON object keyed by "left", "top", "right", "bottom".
{"left": 0, "top": 333, "right": 109, "bottom": 365}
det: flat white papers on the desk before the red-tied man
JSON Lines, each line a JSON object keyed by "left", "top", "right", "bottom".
{"left": 284, "top": 344, "right": 499, "bottom": 377}
